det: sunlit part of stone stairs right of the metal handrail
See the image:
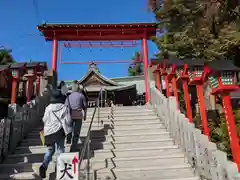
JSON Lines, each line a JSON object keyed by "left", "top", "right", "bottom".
{"left": 91, "top": 106, "right": 199, "bottom": 180}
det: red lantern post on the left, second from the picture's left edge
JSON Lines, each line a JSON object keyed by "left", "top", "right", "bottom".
{"left": 9, "top": 63, "right": 26, "bottom": 104}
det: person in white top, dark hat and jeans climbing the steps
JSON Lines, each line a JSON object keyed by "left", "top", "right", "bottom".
{"left": 39, "top": 90, "right": 72, "bottom": 178}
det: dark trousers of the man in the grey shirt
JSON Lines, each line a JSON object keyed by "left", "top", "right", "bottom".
{"left": 67, "top": 119, "right": 82, "bottom": 152}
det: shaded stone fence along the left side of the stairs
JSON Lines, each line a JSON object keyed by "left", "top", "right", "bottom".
{"left": 0, "top": 90, "right": 50, "bottom": 162}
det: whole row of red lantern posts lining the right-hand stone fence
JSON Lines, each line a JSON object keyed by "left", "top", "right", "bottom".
{"left": 153, "top": 59, "right": 240, "bottom": 172}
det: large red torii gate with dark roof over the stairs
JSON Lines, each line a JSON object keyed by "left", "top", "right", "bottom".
{"left": 37, "top": 23, "right": 157, "bottom": 102}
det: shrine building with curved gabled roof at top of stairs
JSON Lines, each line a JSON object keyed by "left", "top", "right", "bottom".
{"left": 61, "top": 63, "right": 145, "bottom": 106}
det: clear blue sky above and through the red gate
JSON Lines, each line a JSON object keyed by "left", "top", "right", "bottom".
{"left": 0, "top": 0, "right": 157, "bottom": 80}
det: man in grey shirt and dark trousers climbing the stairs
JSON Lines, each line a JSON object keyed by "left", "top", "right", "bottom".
{"left": 65, "top": 83, "right": 87, "bottom": 152}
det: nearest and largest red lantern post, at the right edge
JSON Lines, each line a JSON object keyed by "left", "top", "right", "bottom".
{"left": 207, "top": 60, "right": 240, "bottom": 168}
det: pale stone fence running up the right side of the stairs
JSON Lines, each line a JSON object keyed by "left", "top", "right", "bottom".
{"left": 149, "top": 86, "right": 240, "bottom": 180}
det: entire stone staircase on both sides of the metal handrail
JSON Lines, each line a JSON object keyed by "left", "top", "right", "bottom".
{"left": 0, "top": 106, "right": 199, "bottom": 180}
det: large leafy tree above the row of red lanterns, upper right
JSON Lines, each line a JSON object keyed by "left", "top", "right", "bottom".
{"left": 149, "top": 0, "right": 240, "bottom": 61}
